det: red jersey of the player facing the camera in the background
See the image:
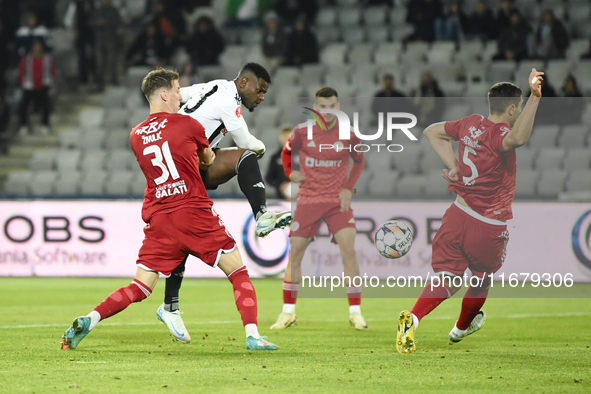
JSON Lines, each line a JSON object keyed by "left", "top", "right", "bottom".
{"left": 281, "top": 122, "right": 365, "bottom": 204}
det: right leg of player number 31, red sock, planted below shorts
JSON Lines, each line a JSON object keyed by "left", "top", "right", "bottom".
{"left": 218, "top": 249, "right": 279, "bottom": 350}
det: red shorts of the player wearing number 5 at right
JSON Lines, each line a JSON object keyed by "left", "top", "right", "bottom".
{"left": 431, "top": 204, "right": 509, "bottom": 277}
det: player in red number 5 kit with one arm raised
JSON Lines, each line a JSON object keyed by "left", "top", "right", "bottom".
{"left": 396, "top": 69, "right": 544, "bottom": 353}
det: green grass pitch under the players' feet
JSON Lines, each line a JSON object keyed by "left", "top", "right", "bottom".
{"left": 0, "top": 278, "right": 591, "bottom": 393}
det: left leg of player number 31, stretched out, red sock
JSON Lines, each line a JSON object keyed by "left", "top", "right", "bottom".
{"left": 61, "top": 267, "right": 158, "bottom": 350}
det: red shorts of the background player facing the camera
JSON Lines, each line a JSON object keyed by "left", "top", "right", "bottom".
{"left": 290, "top": 203, "right": 355, "bottom": 238}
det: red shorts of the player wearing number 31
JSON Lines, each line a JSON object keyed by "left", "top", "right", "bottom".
{"left": 136, "top": 208, "right": 236, "bottom": 276}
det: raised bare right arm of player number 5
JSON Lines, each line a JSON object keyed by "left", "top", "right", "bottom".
{"left": 503, "top": 68, "right": 544, "bottom": 152}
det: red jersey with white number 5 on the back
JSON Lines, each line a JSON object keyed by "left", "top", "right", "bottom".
{"left": 445, "top": 115, "right": 516, "bottom": 221}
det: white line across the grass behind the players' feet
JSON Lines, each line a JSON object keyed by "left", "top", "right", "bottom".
{"left": 0, "top": 312, "right": 591, "bottom": 330}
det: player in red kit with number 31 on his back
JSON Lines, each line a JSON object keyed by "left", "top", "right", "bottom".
{"left": 61, "top": 68, "right": 277, "bottom": 350}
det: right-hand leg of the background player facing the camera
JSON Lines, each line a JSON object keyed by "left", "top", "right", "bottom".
{"left": 334, "top": 227, "right": 368, "bottom": 330}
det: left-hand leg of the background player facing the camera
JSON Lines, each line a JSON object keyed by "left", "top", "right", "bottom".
{"left": 271, "top": 235, "right": 312, "bottom": 330}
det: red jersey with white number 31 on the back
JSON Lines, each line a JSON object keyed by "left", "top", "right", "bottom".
{"left": 129, "top": 112, "right": 213, "bottom": 223}
